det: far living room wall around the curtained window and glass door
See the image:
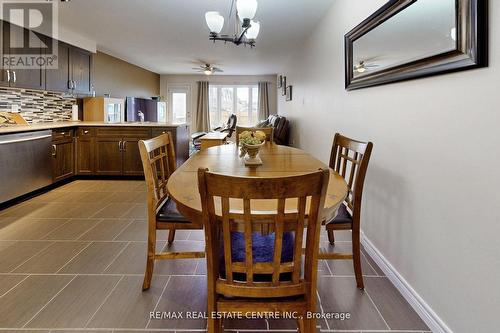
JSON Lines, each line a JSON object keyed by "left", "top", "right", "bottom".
{"left": 161, "top": 75, "right": 278, "bottom": 132}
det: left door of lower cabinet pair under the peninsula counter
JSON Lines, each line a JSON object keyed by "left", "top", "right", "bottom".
{"left": 95, "top": 137, "right": 123, "bottom": 176}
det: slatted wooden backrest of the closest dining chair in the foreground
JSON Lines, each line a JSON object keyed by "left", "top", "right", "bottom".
{"left": 199, "top": 169, "right": 329, "bottom": 298}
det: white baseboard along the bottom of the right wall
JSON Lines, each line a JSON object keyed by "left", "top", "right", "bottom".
{"left": 361, "top": 232, "right": 453, "bottom": 333}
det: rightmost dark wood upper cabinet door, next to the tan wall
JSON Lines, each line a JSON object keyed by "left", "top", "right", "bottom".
{"left": 70, "top": 47, "right": 92, "bottom": 94}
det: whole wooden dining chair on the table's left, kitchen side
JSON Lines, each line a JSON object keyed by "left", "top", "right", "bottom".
{"left": 139, "top": 132, "right": 205, "bottom": 290}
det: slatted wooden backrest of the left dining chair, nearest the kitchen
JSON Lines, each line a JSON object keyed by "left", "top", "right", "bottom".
{"left": 139, "top": 132, "right": 176, "bottom": 205}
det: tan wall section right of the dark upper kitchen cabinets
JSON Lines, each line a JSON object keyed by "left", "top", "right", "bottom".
{"left": 93, "top": 52, "right": 160, "bottom": 98}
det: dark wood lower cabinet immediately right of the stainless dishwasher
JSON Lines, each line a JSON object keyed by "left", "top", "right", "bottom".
{"left": 52, "top": 129, "right": 75, "bottom": 182}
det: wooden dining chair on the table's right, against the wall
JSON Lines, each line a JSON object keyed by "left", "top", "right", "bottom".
{"left": 320, "top": 133, "right": 373, "bottom": 289}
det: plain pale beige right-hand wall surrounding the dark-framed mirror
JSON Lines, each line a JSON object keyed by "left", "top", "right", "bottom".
{"left": 278, "top": 0, "right": 500, "bottom": 333}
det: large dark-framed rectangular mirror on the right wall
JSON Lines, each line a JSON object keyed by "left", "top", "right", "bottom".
{"left": 345, "top": 0, "right": 488, "bottom": 90}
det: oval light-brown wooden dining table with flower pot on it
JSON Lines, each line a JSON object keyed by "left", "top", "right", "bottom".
{"left": 167, "top": 142, "right": 348, "bottom": 223}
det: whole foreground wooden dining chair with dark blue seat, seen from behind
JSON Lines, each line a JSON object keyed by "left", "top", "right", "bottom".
{"left": 198, "top": 169, "right": 329, "bottom": 332}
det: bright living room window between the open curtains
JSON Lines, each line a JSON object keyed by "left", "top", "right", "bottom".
{"left": 209, "top": 85, "right": 259, "bottom": 127}
